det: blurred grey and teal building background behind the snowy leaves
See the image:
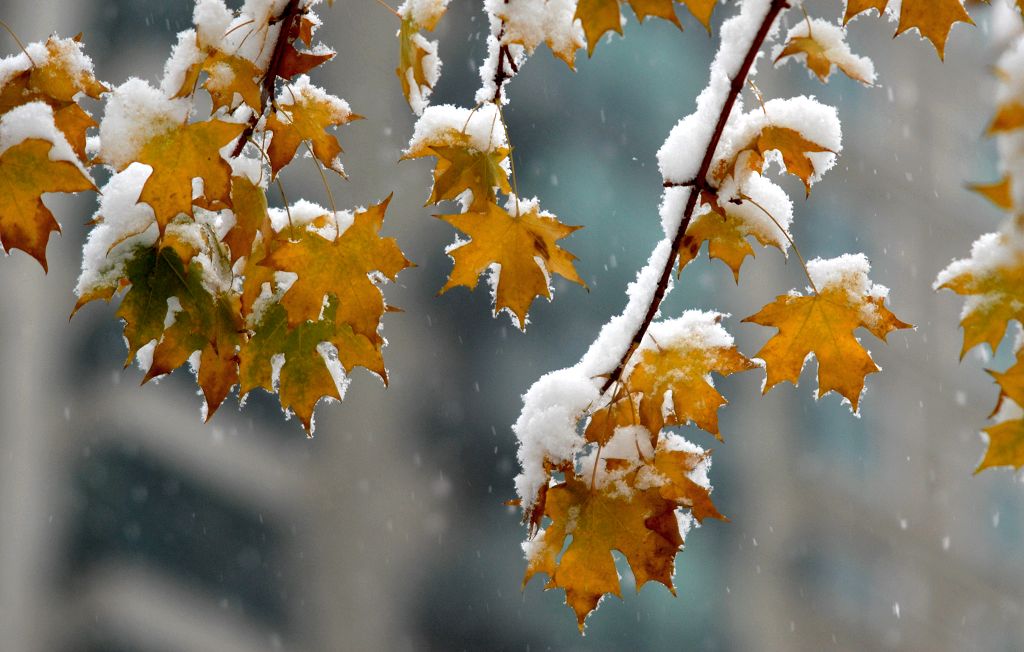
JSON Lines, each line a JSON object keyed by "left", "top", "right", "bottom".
{"left": 0, "top": 0, "right": 1024, "bottom": 652}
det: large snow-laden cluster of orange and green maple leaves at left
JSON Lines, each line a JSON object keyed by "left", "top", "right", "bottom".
{"left": 0, "top": 0, "right": 410, "bottom": 434}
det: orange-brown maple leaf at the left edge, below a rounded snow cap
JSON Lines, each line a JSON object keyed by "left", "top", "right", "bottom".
{"left": 0, "top": 138, "right": 96, "bottom": 271}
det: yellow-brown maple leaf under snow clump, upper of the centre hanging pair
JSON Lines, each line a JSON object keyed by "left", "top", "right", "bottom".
{"left": 402, "top": 129, "right": 512, "bottom": 211}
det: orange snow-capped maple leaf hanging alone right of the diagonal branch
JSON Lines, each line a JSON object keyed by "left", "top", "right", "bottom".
{"left": 743, "top": 256, "right": 912, "bottom": 412}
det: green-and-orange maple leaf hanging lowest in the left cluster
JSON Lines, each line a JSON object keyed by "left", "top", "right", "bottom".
{"left": 238, "top": 298, "right": 387, "bottom": 435}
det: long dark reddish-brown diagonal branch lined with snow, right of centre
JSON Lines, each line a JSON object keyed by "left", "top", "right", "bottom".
{"left": 601, "top": 0, "right": 790, "bottom": 394}
